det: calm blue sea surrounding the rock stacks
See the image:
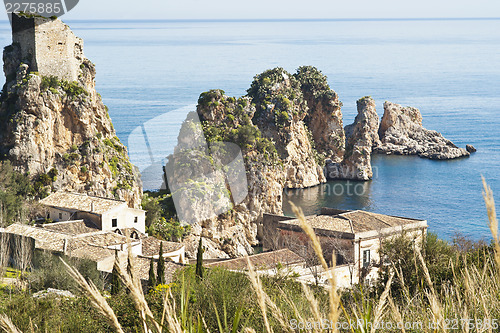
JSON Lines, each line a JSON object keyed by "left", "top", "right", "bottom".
{"left": 0, "top": 17, "right": 500, "bottom": 240}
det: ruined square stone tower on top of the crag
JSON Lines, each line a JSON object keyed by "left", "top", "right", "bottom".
{"left": 12, "top": 13, "right": 85, "bottom": 82}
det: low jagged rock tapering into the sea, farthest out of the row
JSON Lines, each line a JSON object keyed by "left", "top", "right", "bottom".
{"left": 374, "top": 102, "right": 470, "bottom": 160}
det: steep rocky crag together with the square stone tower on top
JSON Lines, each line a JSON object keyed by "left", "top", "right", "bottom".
{"left": 0, "top": 15, "right": 142, "bottom": 207}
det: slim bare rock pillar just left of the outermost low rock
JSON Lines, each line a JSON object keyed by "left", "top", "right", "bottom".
{"left": 326, "top": 97, "right": 380, "bottom": 180}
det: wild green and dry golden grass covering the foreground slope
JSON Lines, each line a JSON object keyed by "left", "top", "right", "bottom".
{"left": 0, "top": 182, "right": 500, "bottom": 333}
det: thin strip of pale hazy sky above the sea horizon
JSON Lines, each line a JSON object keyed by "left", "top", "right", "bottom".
{"left": 63, "top": 0, "right": 500, "bottom": 20}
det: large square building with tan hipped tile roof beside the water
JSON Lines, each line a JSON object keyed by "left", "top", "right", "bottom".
{"left": 262, "top": 208, "right": 428, "bottom": 287}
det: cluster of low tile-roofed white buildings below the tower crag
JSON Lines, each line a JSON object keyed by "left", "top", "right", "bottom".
{"left": 0, "top": 192, "right": 186, "bottom": 281}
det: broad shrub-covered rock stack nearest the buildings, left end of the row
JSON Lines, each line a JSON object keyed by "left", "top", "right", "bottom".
{"left": 171, "top": 90, "right": 286, "bottom": 258}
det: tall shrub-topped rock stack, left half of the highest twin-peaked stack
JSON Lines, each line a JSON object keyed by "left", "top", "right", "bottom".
{"left": 248, "top": 68, "right": 326, "bottom": 188}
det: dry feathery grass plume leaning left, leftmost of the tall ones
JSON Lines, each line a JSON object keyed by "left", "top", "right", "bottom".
{"left": 61, "top": 258, "right": 123, "bottom": 332}
